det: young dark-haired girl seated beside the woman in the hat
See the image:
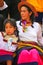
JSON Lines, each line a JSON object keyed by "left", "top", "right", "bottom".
{"left": 0, "top": 19, "right": 18, "bottom": 65}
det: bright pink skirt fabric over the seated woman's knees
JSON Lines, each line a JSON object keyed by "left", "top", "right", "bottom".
{"left": 18, "top": 49, "right": 43, "bottom": 65}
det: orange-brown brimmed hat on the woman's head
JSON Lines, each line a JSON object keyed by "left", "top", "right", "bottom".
{"left": 18, "top": 0, "right": 38, "bottom": 16}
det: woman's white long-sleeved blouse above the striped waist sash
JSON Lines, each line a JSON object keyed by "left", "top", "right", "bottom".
{"left": 17, "top": 21, "right": 43, "bottom": 45}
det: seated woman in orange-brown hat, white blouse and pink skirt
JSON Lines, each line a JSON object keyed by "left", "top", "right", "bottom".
{"left": 17, "top": 1, "right": 43, "bottom": 65}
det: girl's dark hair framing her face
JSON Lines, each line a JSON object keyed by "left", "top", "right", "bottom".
{"left": 4, "top": 18, "right": 18, "bottom": 36}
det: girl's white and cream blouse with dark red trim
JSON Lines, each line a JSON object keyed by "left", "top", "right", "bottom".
{"left": 0, "top": 32, "right": 18, "bottom": 52}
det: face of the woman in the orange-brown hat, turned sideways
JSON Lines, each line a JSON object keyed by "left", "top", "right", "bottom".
{"left": 20, "top": 6, "right": 30, "bottom": 20}
